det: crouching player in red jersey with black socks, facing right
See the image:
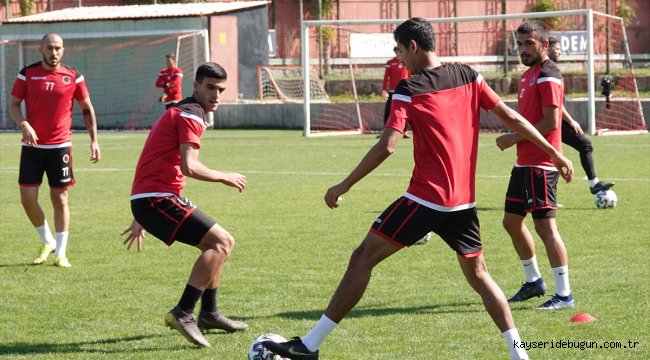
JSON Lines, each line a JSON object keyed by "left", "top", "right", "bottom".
{"left": 122, "top": 63, "right": 248, "bottom": 347}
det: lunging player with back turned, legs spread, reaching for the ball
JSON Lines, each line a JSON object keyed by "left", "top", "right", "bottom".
{"left": 263, "top": 18, "right": 573, "bottom": 359}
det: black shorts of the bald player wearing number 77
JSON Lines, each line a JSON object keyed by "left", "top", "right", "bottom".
{"left": 18, "top": 146, "right": 75, "bottom": 189}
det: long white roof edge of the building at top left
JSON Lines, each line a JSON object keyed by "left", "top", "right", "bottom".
{"left": 5, "top": 1, "right": 269, "bottom": 24}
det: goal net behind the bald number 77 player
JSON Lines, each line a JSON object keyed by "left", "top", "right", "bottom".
{"left": 0, "top": 31, "right": 208, "bottom": 129}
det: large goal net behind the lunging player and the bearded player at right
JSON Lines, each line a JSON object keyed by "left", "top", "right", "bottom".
{"left": 302, "top": 10, "right": 646, "bottom": 136}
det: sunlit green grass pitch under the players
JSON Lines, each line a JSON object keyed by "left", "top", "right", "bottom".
{"left": 0, "top": 130, "right": 650, "bottom": 360}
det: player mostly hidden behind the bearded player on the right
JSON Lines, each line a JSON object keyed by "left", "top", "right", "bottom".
{"left": 548, "top": 36, "right": 614, "bottom": 194}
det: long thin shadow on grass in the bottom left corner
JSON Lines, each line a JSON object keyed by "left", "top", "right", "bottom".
{"left": 0, "top": 335, "right": 167, "bottom": 355}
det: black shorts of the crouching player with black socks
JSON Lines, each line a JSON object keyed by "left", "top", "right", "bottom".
{"left": 131, "top": 195, "right": 216, "bottom": 246}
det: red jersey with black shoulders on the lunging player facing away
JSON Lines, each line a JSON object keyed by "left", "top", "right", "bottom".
{"left": 386, "top": 64, "right": 501, "bottom": 211}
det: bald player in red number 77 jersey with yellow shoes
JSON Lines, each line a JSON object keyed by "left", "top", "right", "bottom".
{"left": 8, "top": 33, "right": 101, "bottom": 267}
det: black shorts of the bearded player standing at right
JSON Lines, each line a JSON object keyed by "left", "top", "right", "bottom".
{"left": 505, "top": 167, "right": 560, "bottom": 219}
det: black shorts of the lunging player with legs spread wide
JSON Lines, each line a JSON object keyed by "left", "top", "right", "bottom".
{"left": 370, "top": 196, "right": 483, "bottom": 257}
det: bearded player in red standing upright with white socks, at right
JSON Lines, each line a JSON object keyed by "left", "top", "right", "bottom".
{"left": 497, "top": 20, "right": 575, "bottom": 310}
